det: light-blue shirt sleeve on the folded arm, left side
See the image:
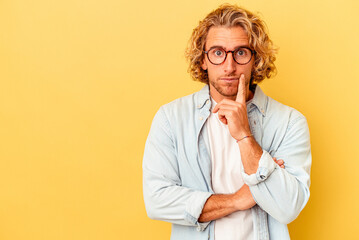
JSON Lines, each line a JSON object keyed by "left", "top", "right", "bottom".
{"left": 143, "top": 108, "right": 211, "bottom": 231}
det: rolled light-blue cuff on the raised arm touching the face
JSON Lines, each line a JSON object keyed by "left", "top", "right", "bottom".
{"left": 242, "top": 150, "right": 277, "bottom": 186}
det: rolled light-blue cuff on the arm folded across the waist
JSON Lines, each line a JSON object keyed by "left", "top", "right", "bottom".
{"left": 185, "top": 192, "right": 212, "bottom": 231}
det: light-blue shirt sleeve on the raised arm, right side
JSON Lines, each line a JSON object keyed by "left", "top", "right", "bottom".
{"left": 242, "top": 115, "right": 312, "bottom": 224}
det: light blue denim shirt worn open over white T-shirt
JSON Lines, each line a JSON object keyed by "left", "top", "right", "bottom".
{"left": 143, "top": 85, "right": 311, "bottom": 240}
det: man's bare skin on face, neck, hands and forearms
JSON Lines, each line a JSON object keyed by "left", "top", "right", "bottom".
{"left": 198, "top": 27, "right": 284, "bottom": 222}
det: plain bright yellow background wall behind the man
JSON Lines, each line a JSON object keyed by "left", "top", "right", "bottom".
{"left": 0, "top": 0, "right": 359, "bottom": 240}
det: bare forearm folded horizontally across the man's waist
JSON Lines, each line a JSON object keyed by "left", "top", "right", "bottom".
{"left": 198, "top": 185, "right": 256, "bottom": 222}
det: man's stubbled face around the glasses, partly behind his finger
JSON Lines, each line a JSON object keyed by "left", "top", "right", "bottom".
{"left": 202, "top": 27, "right": 254, "bottom": 102}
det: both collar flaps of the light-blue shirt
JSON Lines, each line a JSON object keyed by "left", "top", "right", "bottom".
{"left": 196, "top": 84, "right": 267, "bottom": 116}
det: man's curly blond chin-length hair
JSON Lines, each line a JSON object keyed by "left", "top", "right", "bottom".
{"left": 185, "top": 4, "right": 277, "bottom": 85}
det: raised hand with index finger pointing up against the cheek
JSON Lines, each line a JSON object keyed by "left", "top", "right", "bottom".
{"left": 212, "top": 74, "right": 251, "bottom": 140}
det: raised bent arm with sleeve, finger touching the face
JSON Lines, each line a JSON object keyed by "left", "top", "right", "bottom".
{"left": 213, "top": 74, "right": 311, "bottom": 224}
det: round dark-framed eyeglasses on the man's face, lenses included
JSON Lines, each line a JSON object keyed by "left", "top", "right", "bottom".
{"left": 203, "top": 47, "right": 255, "bottom": 65}
